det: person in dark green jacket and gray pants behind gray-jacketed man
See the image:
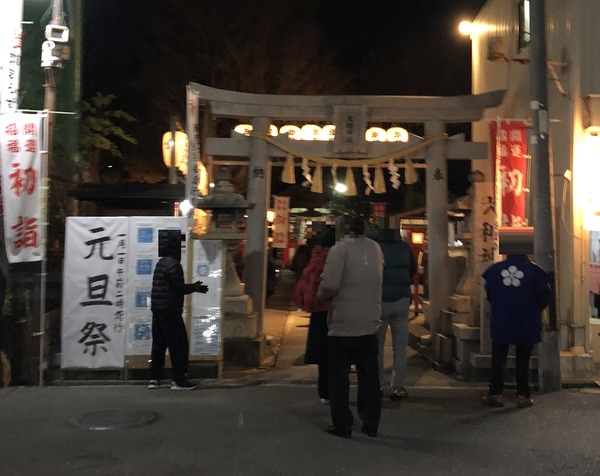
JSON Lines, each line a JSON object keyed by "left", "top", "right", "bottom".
{"left": 369, "top": 219, "right": 417, "bottom": 401}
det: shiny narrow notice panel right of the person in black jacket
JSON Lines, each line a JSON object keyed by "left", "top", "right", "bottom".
{"left": 190, "top": 240, "right": 225, "bottom": 357}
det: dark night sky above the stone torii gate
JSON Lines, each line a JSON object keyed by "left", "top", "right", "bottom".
{"left": 83, "top": 0, "right": 485, "bottom": 199}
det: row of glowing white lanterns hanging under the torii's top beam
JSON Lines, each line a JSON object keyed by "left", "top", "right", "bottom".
{"left": 233, "top": 124, "right": 409, "bottom": 142}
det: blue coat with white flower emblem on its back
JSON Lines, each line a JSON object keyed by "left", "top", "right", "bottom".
{"left": 482, "top": 255, "right": 552, "bottom": 345}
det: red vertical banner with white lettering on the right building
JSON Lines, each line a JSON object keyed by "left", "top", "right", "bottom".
{"left": 490, "top": 120, "right": 527, "bottom": 227}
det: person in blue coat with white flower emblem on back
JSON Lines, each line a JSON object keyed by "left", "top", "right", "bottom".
{"left": 481, "top": 255, "right": 552, "bottom": 408}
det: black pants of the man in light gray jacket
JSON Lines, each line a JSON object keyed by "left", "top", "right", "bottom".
{"left": 328, "top": 334, "right": 381, "bottom": 432}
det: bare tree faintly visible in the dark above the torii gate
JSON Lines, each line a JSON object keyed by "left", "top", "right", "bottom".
{"left": 140, "top": 0, "right": 348, "bottom": 121}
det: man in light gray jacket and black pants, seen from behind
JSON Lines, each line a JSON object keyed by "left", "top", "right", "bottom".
{"left": 317, "top": 217, "right": 383, "bottom": 438}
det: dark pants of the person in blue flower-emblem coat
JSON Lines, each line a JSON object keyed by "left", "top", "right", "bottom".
{"left": 490, "top": 342, "right": 533, "bottom": 397}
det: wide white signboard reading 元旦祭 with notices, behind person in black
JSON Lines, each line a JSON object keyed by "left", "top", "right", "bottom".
{"left": 61, "top": 217, "right": 225, "bottom": 369}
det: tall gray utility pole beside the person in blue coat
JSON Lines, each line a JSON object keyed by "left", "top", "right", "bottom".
{"left": 529, "top": 0, "right": 561, "bottom": 393}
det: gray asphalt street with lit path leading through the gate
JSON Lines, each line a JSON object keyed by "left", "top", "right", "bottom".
{"left": 0, "top": 310, "right": 600, "bottom": 476}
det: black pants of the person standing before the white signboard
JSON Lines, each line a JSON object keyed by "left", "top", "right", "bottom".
{"left": 150, "top": 313, "right": 190, "bottom": 382}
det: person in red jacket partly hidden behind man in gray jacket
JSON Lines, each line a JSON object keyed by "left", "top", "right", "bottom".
{"left": 293, "top": 227, "right": 335, "bottom": 405}
